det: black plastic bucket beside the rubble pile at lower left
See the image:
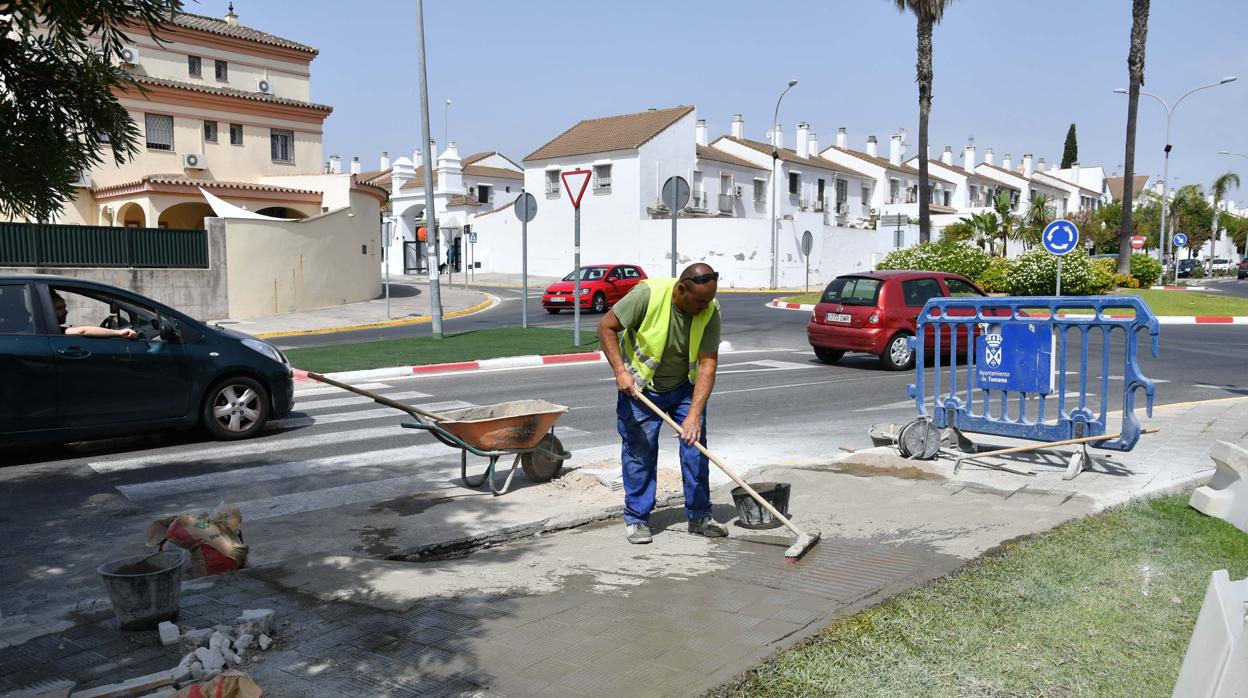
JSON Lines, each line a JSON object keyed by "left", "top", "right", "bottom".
{"left": 96, "top": 548, "right": 186, "bottom": 631}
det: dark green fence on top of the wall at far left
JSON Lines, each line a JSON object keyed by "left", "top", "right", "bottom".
{"left": 0, "top": 222, "right": 208, "bottom": 268}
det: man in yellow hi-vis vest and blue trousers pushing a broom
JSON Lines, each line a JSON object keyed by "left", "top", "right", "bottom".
{"left": 598, "top": 263, "right": 728, "bottom": 543}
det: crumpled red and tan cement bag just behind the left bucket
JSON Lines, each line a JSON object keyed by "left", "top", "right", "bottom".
{"left": 147, "top": 506, "right": 247, "bottom": 577}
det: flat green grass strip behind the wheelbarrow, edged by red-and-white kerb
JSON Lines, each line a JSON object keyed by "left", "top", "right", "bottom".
{"left": 285, "top": 326, "right": 598, "bottom": 373}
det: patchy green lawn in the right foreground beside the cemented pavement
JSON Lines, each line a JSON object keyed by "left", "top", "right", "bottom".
{"left": 714, "top": 493, "right": 1248, "bottom": 698}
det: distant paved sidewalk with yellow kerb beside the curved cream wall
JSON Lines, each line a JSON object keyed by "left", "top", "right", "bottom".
{"left": 213, "top": 276, "right": 495, "bottom": 337}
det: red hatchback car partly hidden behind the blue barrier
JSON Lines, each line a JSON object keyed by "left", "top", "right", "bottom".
{"left": 806, "top": 271, "right": 987, "bottom": 371}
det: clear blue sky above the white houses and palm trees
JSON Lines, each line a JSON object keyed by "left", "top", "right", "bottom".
{"left": 227, "top": 0, "right": 1248, "bottom": 197}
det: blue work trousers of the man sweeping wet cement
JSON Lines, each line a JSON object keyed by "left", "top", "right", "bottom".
{"left": 615, "top": 381, "right": 710, "bottom": 523}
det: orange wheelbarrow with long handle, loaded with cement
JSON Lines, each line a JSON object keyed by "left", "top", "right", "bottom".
{"left": 308, "top": 371, "right": 572, "bottom": 496}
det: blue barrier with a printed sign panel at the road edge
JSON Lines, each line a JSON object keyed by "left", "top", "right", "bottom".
{"left": 909, "top": 296, "right": 1161, "bottom": 451}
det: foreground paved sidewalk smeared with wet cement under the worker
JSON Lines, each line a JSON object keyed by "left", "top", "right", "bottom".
{"left": 0, "top": 398, "right": 1248, "bottom": 698}
